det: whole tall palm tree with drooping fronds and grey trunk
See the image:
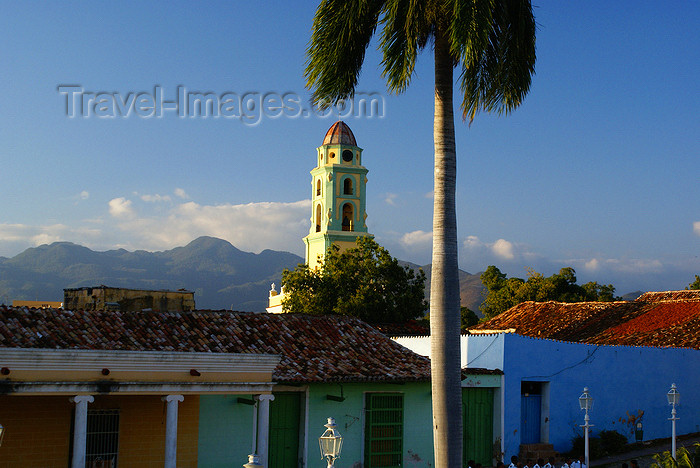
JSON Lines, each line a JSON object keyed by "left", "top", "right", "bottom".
{"left": 306, "top": 0, "right": 536, "bottom": 468}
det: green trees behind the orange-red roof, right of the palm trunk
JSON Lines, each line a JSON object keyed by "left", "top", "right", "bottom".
{"left": 479, "top": 265, "right": 619, "bottom": 318}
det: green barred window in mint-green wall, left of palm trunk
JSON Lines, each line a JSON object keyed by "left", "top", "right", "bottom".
{"left": 365, "top": 393, "right": 403, "bottom": 468}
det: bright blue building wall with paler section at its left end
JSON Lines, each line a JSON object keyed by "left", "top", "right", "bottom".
{"left": 467, "top": 334, "right": 700, "bottom": 459}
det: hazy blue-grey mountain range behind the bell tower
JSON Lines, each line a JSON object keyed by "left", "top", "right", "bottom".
{"left": 0, "top": 237, "right": 484, "bottom": 311}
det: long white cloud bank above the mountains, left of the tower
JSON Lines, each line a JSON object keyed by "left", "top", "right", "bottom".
{"left": 0, "top": 197, "right": 311, "bottom": 256}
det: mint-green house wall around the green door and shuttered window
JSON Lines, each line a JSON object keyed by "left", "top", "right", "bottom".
{"left": 198, "top": 382, "right": 434, "bottom": 468}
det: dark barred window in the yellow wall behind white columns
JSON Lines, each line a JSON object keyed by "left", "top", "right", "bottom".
{"left": 85, "top": 410, "right": 119, "bottom": 468}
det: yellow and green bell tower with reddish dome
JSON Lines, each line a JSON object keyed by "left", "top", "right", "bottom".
{"left": 304, "top": 121, "right": 370, "bottom": 268}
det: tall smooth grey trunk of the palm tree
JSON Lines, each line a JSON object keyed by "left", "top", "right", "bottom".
{"left": 430, "top": 31, "right": 462, "bottom": 468}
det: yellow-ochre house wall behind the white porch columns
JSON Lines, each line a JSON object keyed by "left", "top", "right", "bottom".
{"left": 0, "top": 395, "right": 199, "bottom": 468}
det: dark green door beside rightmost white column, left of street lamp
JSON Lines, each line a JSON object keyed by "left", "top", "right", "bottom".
{"left": 268, "top": 392, "right": 302, "bottom": 468}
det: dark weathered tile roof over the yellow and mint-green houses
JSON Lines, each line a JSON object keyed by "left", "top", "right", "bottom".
{"left": 0, "top": 306, "right": 430, "bottom": 382}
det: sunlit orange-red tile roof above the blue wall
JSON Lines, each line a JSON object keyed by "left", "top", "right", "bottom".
{"left": 470, "top": 291, "right": 700, "bottom": 349}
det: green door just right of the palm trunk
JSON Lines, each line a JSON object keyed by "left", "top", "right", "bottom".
{"left": 462, "top": 388, "right": 493, "bottom": 466}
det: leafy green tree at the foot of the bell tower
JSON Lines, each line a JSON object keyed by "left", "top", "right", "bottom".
{"left": 282, "top": 236, "right": 428, "bottom": 323}
